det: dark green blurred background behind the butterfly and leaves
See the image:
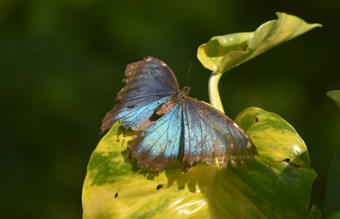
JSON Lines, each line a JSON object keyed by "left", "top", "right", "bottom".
{"left": 0, "top": 0, "right": 340, "bottom": 218}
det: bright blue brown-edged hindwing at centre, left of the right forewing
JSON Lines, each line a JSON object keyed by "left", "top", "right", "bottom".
{"left": 129, "top": 104, "right": 184, "bottom": 171}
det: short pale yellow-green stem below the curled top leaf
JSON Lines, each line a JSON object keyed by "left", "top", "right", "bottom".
{"left": 208, "top": 71, "right": 224, "bottom": 113}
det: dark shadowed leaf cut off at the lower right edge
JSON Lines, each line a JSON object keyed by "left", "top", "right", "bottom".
{"left": 325, "top": 150, "right": 340, "bottom": 218}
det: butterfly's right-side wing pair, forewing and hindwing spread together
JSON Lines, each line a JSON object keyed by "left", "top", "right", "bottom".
{"left": 129, "top": 97, "right": 257, "bottom": 171}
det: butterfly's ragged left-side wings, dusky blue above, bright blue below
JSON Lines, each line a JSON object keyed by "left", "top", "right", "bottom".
{"left": 101, "top": 57, "right": 179, "bottom": 132}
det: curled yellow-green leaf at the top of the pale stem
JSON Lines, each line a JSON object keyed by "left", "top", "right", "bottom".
{"left": 197, "top": 12, "right": 321, "bottom": 73}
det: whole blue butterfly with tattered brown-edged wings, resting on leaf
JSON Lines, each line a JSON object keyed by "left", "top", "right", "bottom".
{"left": 101, "top": 57, "right": 257, "bottom": 171}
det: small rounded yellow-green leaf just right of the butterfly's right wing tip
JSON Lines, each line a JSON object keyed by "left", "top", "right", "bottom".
{"left": 235, "top": 107, "right": 309, "bottom": 167}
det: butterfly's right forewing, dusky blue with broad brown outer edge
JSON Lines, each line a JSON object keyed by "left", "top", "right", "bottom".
{"left": 182, "top": 97, "right": 257, "bottom": 167}
